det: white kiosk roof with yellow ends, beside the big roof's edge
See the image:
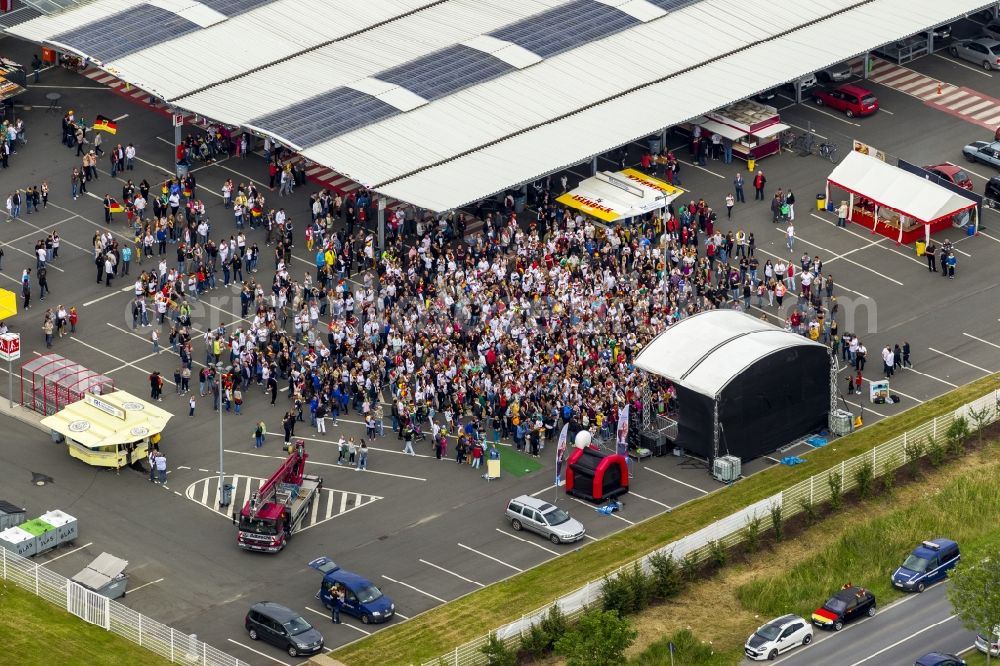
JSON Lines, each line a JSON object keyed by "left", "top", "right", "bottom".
{"left": 556, "top": 169, "right": 684, "bottom": 222}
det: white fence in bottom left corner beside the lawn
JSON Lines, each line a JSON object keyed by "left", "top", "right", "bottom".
{"left": 0, "top": 548, "right": 248, "bottom": 666}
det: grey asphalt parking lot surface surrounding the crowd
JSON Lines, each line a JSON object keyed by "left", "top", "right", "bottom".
{"left": 0, "top": 19, "right": 1000, "bottom": 664}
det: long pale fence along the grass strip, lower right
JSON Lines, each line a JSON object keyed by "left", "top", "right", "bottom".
{"left": 421, "top": 390, "right": 1000, "bottom": 666}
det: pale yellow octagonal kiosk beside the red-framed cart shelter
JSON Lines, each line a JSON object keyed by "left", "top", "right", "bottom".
{"left": 42, "top": 391, "right": 172, "bottom": 469}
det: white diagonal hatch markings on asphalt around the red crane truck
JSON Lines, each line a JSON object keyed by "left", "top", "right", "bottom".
{"left": 184, "top": 474, "right": 384, "bottom": 532}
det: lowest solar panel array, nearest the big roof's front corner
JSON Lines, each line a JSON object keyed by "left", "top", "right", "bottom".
{"left": 250, "top": 88, "right": 399, "bottom": 148}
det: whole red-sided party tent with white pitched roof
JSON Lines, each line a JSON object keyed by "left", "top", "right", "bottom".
{"left": 826, "top": 150, "right": 979, "bottom": 244}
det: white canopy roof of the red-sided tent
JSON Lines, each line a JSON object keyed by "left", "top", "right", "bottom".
{"left": 827, "top": 150, "right": 976, "bottom": 224}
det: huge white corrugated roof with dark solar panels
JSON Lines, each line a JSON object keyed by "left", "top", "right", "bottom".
{"left": 8, "top": 0, "right": 988, "bottom": 210}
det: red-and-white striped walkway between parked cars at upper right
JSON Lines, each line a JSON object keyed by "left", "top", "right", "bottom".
{"left": 868, "top": 58, "right": 1000, "bottom": 130}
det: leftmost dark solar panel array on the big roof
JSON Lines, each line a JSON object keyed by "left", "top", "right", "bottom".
{"left": 50, "top": 4, "right": 199, "bottom": 62}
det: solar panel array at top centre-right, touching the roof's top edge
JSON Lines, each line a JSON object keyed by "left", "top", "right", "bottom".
{"left": 489, "top": 0, "right": 641, "bottom": 58}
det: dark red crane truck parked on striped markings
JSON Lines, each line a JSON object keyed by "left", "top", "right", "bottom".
{"left": 237, "top": 439, "right": 323, "bottom": 553}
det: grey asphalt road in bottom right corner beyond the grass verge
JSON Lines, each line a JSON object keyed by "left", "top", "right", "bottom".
{"left": 768, "top": 582, "right": 976, "bottom": 666}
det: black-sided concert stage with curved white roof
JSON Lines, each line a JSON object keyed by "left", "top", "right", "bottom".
{"left": 635, "top": 310, "right": 836, "bottom": 460}
